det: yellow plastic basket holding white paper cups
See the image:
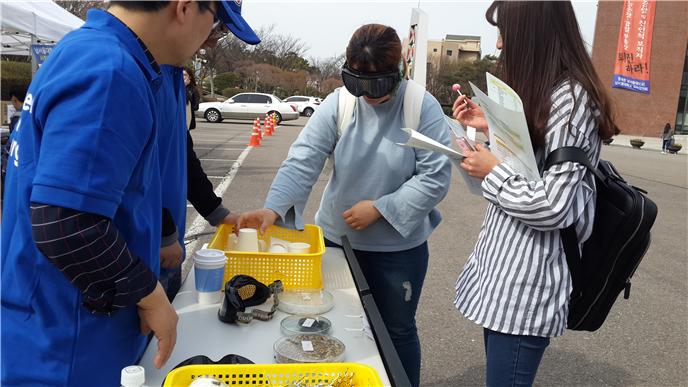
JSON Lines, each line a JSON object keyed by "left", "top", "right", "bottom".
{"left": 208, "top": 224, "right": 325, "bottom": 290}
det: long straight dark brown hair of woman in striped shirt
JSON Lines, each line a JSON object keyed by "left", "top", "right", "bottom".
{"left": 485, "top": 1, "right": 619, "bottom": 148}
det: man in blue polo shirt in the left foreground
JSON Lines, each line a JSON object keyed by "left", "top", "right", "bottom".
{"left": 0, "top": 0, "right": 258, "bottom": 386}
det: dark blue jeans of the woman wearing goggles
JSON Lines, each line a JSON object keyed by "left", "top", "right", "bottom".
{"left": 325, "top": 240, "right": 429, "bottom": 386}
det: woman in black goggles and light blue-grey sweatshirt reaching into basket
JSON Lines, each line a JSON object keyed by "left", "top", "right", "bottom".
{"left": 239, "top": 24, "right": 451, "bottom": 386}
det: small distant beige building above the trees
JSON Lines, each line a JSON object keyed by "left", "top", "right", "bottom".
{"left": 428, "top": 35, "right": 482, "bottom": 68}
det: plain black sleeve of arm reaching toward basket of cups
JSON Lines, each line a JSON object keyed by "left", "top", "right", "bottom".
{"left": 186, "top": 132, "right": 222, "bottom": 218}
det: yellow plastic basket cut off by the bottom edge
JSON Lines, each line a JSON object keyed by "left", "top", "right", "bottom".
{"left": 163, "top": 363, "right": 383, "bottom": 387}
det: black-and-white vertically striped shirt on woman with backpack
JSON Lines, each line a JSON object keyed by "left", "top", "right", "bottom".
{"left": 454, "top": 82, "right": 601, "bottom": 337}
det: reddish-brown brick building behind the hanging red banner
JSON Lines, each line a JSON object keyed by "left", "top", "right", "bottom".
{"left": 592, "top": 0, "right": 688, "bottom": 137}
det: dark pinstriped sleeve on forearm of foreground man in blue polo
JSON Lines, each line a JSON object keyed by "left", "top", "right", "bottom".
{"left": 31, "top": 203, "right": 158, "bottom": 315}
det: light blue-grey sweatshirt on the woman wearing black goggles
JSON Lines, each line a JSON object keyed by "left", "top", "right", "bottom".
{"left": 265, "top": 81, "right": 451, "bottom": 251}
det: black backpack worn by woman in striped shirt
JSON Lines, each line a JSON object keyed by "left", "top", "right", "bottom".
{"left": 545, "top": 147, "right": 657, "bottom": 331}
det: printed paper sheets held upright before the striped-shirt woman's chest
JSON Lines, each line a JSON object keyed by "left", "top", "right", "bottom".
{"left": 470, "top": 73, "right": 541, "bottom": 181}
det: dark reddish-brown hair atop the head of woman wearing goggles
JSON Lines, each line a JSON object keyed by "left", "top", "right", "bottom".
{"left": 346, "top": 24, "right": 401, "bottom": 73}
